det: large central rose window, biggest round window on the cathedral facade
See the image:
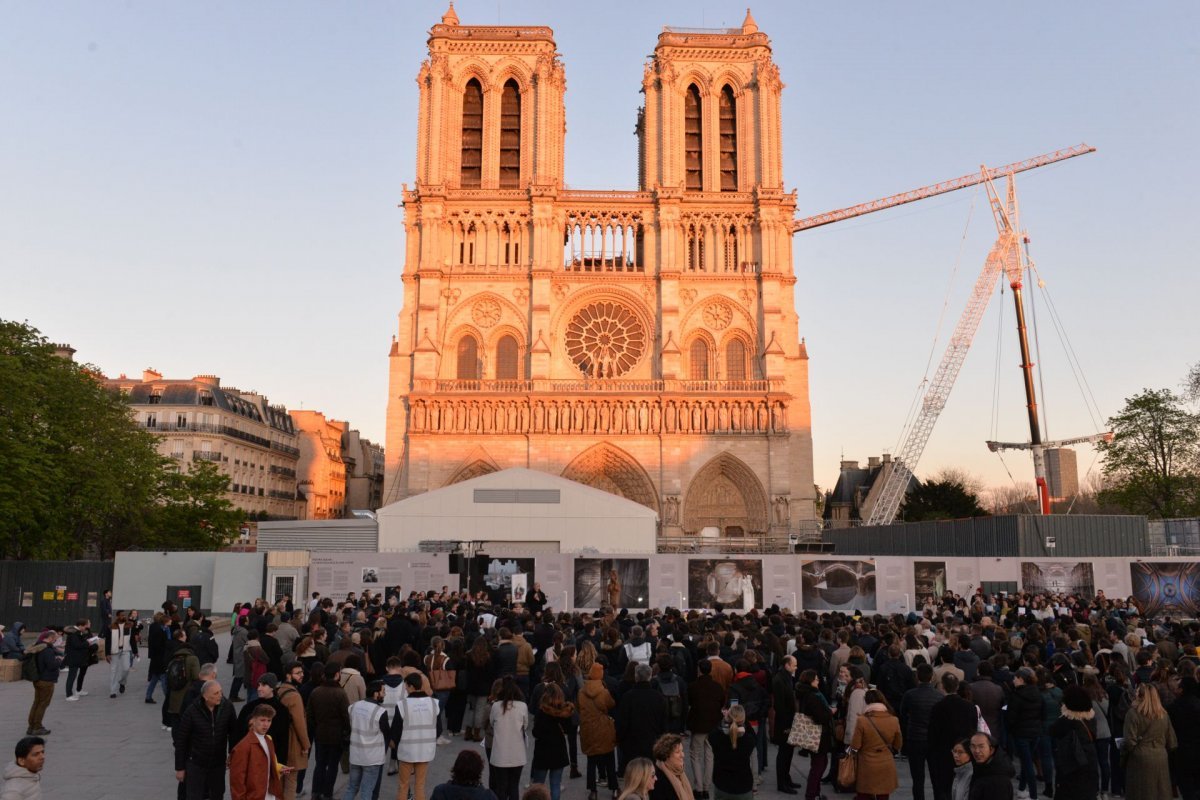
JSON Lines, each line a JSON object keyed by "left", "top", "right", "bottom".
{"left": 566, "top": 302, "right": 646, "bottom": 378}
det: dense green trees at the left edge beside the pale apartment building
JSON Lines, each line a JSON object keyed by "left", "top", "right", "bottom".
{"left": 0, "top": 320, "right": 240, "bottom": 559}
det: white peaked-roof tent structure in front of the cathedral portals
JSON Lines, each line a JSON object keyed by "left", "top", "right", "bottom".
{"left": 377, "top": 468, "right": 658, "bottom": 553}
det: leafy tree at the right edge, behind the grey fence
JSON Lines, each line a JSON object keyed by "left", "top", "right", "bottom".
{"left": 1099, "top": 389, "right": 1200, "bottom": 518}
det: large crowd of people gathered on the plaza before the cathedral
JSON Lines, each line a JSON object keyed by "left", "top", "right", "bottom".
{"left": 0, "top": 584, "right": 1200, "bottom": 800}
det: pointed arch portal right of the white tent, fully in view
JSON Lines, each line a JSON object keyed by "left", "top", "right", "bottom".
{"left": 683, "top": 453, "right": 768, "bottom": 536}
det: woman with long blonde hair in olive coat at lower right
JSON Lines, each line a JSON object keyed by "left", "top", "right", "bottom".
{"left": 1121, "top": 684, "right": 1178, "bottom": 800}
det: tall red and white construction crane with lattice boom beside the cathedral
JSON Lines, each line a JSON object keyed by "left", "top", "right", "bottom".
{"left": 792, "top": 144, "right": 1096, "bottom": 525}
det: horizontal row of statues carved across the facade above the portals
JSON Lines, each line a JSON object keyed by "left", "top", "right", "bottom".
{"left": 410, "top": 398, "right": 787, "bottom": 435}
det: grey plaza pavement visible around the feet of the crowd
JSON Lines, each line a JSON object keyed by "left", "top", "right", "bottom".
{"left": 0, "top": 633, "right": 912, "bottom": 800}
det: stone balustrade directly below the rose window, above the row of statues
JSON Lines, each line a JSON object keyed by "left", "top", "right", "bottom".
{"left": 414, "top": 378, "right": 784, "bottom": 395}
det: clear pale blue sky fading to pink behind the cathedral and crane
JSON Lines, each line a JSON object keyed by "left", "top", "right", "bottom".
{"left": 0, "top": 0, "right": 1200, "bottom": 496}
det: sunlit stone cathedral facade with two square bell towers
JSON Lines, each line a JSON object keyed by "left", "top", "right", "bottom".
{"left": 384, "top": 6, "right": 815, "bottom": 536}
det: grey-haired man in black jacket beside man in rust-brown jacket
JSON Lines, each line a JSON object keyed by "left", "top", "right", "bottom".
{"left": 174, "top": 680, "right": 235, "bottom": 800}
